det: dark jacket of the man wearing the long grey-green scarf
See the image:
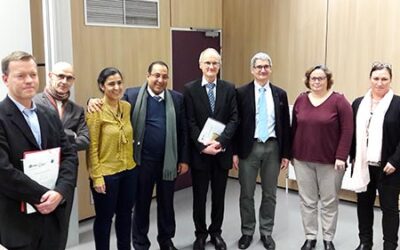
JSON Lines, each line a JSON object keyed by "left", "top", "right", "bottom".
{"left": 122, "top": 87, "right": 189, "bottom": 166}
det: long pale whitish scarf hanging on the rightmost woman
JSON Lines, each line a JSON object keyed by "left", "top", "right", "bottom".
{"left": 350, "top": 89, "right": 394, "bottom": 193}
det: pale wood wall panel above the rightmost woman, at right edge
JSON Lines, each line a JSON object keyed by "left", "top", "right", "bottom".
{"left": 327, "top": 0, "right": 400, "bottom": 101}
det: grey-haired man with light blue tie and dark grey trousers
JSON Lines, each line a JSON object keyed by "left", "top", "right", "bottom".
{"left": 233, "top": 52, "right": 290, "bottom": 249}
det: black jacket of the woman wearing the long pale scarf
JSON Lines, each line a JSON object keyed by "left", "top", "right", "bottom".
{"left": 350, "top": 95, "right": 400, "bottom": 188}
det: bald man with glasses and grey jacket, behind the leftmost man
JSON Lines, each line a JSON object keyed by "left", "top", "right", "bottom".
{"left": 33, "top": 62, "right": 89, "bottom": 249}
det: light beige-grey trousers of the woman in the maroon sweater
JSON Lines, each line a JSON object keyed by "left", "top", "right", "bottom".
{"left": 294, "top": 159, "right": 344, "bottom": 241}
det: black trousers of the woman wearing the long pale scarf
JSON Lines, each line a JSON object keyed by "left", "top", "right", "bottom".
{"left": 357, "top": 166, "right": 399, "bottom": 250}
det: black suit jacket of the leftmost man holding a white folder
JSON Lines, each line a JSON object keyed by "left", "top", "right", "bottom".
{"left": 0, "top": 97, "right": 77, "bottom": 248}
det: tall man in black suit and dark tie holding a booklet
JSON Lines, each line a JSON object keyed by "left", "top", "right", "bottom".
{"left": 184, "top": 48, "right": 238, "bottom": 250}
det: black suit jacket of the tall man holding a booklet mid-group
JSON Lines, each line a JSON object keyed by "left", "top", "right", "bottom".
{"left": 184, "top": 79, "right": 239, "bottom": 169}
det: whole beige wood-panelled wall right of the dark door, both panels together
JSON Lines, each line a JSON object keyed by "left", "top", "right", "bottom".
{"left": 222, "top": 0, "right": 400, "bottom": 103}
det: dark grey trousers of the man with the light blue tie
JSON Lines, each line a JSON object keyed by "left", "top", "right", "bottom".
{"left": 239, "top": 139, "right": 280, "bottom": 236}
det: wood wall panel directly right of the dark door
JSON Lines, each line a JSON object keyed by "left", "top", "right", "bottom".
{"left": 223, "top": 0, "right": 327, "bottom": 103}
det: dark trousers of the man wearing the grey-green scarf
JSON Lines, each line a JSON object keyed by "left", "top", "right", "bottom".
{"left": 132, "top": 160, "right": 176, "bottom": 250}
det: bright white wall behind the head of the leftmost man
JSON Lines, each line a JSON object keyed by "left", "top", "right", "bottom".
{"left": 0, "top": 0, "right": 32, "bottom": 100}
